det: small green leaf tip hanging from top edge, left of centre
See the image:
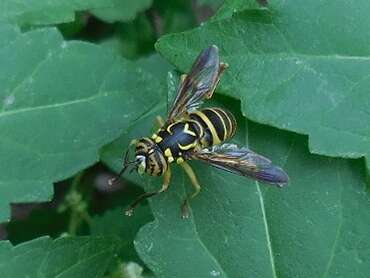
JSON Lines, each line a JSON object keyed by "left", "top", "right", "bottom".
{"left": 91, "top": 0, "right": 152, "bottom": 23}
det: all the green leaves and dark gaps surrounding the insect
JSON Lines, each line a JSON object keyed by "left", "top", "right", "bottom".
{"left": 0, "top": 0, "right": 370, "bottom": 277}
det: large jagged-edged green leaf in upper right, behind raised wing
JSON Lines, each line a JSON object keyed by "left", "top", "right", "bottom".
{"left": 157, "top": 0, "right": 370, "bottom": 170}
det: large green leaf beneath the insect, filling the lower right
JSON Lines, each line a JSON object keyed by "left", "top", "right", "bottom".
{"left": 102, "top": 87, "right": 370, "bottom": 277}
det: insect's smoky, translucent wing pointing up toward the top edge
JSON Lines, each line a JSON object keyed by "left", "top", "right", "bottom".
{"left": 167, "top": 45, "right": 227, "bottom": 123}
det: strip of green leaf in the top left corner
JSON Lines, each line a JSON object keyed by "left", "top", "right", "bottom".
{"left": 0, "top": 0, "right": 121, "bottom": 25}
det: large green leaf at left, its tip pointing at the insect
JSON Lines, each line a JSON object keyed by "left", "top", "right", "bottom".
{"left": 0, "top": 26, "right": 162, "bottom": 223}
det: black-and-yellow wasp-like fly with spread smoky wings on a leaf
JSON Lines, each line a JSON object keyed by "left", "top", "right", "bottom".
{"left": 110, "top": 45, "right": 288, "bottom": 218}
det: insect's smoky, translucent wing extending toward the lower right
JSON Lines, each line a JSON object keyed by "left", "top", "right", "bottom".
{"left": 191, "top": 144, "right": 289, "bottom": 186}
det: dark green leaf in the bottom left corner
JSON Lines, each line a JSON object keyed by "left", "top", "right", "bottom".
{"left": 0, "top": 237, "right": 117, "bottom": 278}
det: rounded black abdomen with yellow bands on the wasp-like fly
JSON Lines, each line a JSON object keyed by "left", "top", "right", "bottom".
{"left": 189, "top": 108, "right": 236, "bottom": 148}
